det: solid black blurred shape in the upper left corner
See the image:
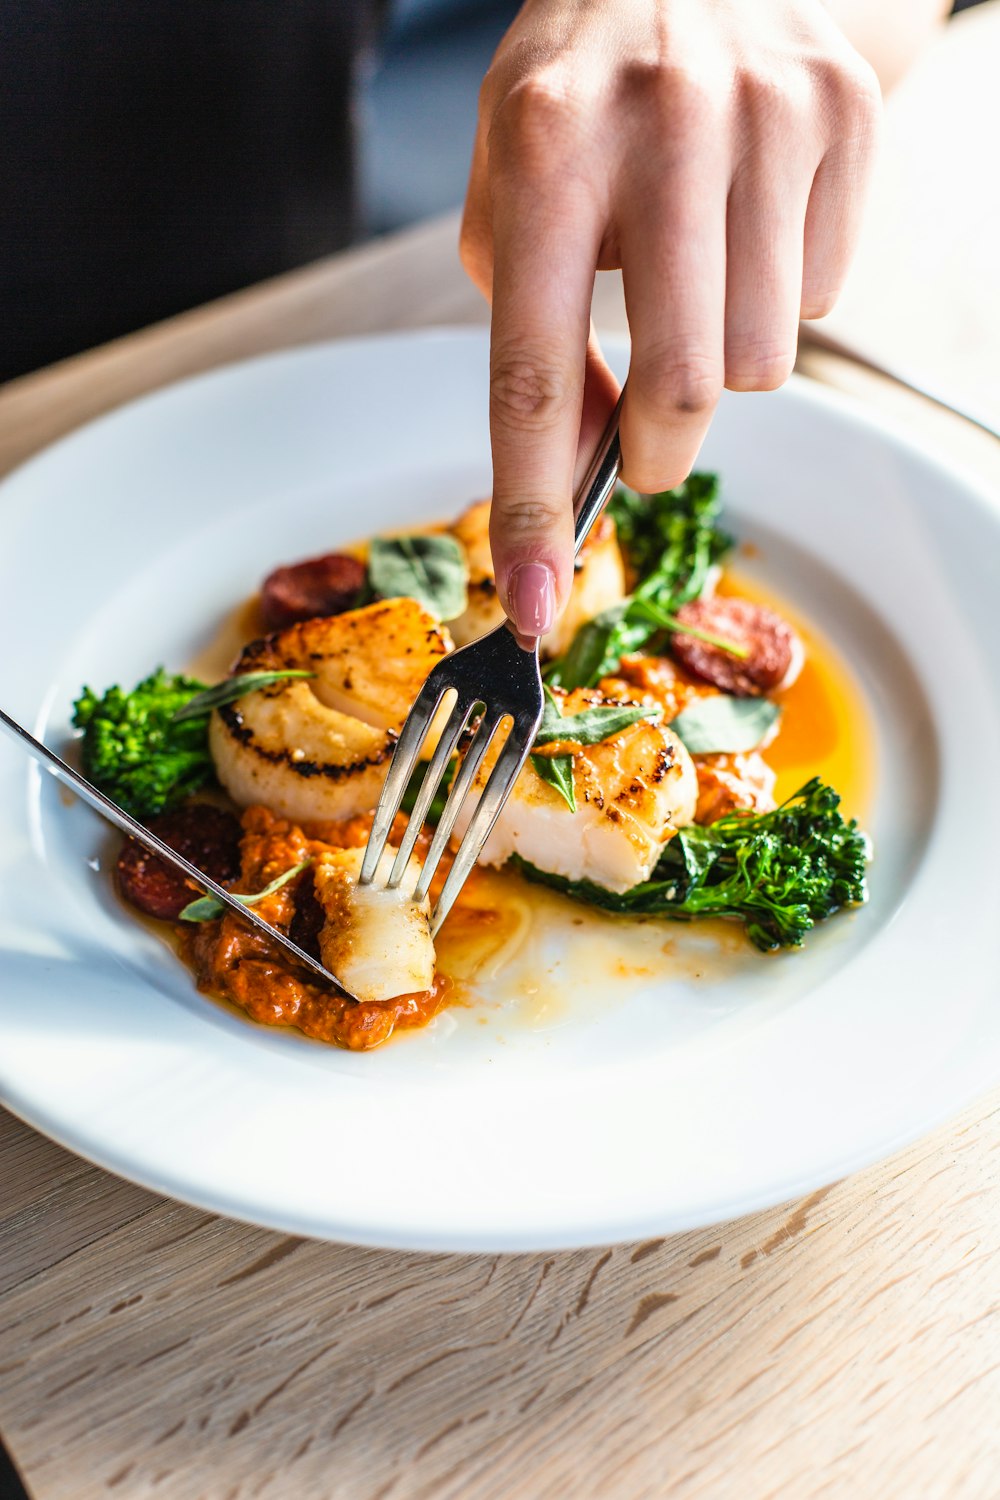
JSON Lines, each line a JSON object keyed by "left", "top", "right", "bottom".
{"left": 0, "top": 0, "right": 375, "bottom": 380}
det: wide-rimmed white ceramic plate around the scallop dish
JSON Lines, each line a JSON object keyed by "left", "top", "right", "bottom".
{"left": 0, "top": 330, "right": 1000, "bottom": 1251}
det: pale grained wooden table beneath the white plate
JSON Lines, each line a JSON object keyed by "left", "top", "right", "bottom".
{"left": 0, "top": 5, "right": 1000, "bottom": 1500}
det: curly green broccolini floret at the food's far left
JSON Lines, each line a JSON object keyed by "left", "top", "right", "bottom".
{"left": 73, "top": 668, "right": 216, "bottom": 821}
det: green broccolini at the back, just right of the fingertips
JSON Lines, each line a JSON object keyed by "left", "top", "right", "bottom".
{"left": 546, "top": 474, "right": 747, "bottom": 689}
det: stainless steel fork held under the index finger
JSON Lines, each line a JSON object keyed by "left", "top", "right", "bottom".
{"left": 358, "top": 398, "right": 622, "bottom": 933}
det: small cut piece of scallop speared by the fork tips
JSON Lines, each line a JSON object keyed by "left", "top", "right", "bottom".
{"left": 313, "top": 846, "right": 435, "bottom": 1001}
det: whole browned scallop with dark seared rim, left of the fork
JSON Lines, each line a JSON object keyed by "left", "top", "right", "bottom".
{"left": 208, "top": 599, "right": 451, "bottom": 822}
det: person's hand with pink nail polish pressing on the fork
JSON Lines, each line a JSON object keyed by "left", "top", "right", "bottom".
{"left": 460, "top": 0, "right": 880, "bottom": 636}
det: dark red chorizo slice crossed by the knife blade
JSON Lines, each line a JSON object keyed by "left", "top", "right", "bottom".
{"left": 117, "top": 803, "right": 240, "bottom": 923}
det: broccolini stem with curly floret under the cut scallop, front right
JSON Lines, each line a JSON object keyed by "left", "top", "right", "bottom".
{"left": 514, "top": 777, "right": 871, "bottom": 953}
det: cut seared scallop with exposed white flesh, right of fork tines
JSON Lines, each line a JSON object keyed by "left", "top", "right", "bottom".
{"left": 456, "top": 689, "right": 697, "bottom": 891}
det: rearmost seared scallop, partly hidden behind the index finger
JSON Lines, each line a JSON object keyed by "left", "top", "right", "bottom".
{"left": 448, "top": 500, "right": 625, "bottom": 657}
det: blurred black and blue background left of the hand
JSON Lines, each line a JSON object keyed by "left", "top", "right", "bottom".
{"left": 0, "top": 0, "right": 1000, "bottom": 381}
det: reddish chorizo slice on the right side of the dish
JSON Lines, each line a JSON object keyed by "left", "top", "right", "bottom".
{"left": 672, "top": 596, "right": 805, "bottom": 698}
